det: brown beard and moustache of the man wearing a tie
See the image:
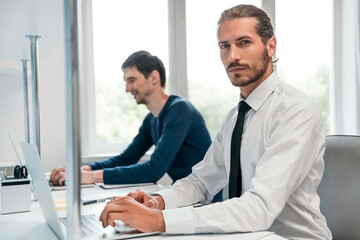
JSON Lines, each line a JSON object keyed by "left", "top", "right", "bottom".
{"left": 226, "top": 48, "right": 270, "bottom": 87}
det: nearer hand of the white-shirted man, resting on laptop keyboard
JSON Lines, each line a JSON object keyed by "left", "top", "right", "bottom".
{"left": 99, "top": 196, "right": 165, "bottom": 232}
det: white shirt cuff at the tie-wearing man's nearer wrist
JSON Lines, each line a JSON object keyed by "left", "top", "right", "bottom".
{"left": 162, "top": 207, "right": 195, "bottom": 234}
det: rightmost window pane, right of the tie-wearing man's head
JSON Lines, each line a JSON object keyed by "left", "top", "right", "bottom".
{"left": 275, "top": 0, "right": 333, "bottom": 133}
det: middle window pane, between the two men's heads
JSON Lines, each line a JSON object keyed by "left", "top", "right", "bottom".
{"left": 186, "top": 0, "right": 261, "bottom": 136}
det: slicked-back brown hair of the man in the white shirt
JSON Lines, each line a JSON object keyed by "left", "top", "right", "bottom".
{"left": 218, "top": 4, "right": 274, "bottom": 44}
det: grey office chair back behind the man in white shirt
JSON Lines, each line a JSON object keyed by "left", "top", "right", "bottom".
{"left": 318, "top": 135, "right": 360, "bottom": 240}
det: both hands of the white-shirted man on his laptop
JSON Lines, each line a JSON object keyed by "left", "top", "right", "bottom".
{"left": 100, "top": 190, "right": 165, "bottom": 232}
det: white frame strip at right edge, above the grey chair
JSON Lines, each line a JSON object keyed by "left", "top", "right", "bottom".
{"left": 330, "top": 0, "right": 360, "bottom": 135}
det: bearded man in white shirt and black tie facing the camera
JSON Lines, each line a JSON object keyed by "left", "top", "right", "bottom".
{"left": 100, "top": 5, "right": 331, "bottom": 239}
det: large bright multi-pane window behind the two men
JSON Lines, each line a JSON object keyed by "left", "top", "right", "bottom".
{"left": 84, "top": 0, "right": 333, "bottom": 154}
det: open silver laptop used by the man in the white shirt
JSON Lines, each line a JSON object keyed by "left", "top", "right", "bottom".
{"left": 21, "top": 142, "right": 159, "bottom": 239}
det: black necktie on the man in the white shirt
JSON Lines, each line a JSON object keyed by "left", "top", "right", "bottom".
{"left": 229, "top": 101, "right": 251, "bottom": 198}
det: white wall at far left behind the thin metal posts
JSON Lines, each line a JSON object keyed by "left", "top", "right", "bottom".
{"left": 0, "top": 0, "right": 66, "bottom": 171}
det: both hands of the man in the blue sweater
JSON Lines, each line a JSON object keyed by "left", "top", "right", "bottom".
{"left": 50, "top": 165, "right": 104, "bottom": 186}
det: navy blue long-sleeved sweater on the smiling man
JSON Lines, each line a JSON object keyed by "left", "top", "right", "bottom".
{"left": 90, "top": 95, "right": 211, "bottom": 184}
